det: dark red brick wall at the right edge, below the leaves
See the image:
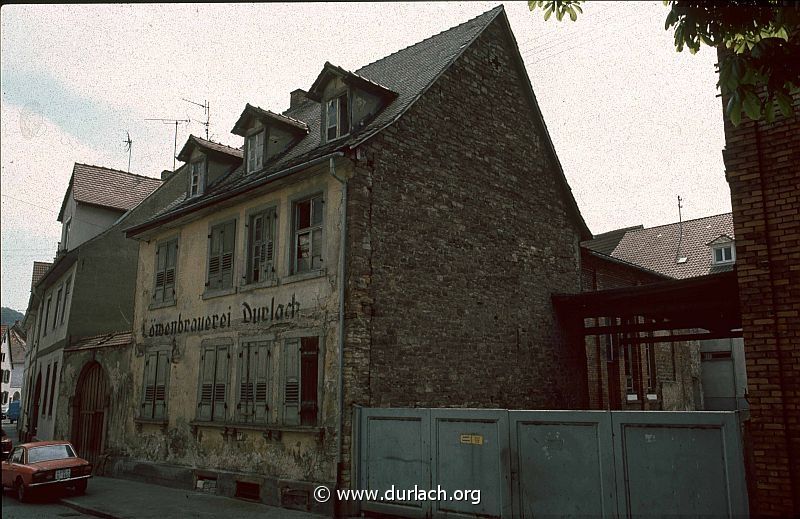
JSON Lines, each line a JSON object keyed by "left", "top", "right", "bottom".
{"left": 723, "top": 87, "right": 800, "bottom": 516}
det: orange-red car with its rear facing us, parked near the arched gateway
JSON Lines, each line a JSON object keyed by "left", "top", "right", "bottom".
{"left": 2, "top": 441, "right": 92, "bottom": 501}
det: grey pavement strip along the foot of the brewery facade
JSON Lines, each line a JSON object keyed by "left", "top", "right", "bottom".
{"left": 61, "top": 476, "right": 325, "bottom": 519}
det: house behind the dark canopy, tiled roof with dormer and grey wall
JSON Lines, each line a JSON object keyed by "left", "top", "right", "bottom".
{"left": 583, "top": 213, "right": 747, "bottom": 410}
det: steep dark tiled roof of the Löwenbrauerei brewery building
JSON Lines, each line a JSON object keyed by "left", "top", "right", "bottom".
{"left": 126, "top": 5, "right": 591, "bottom": 238}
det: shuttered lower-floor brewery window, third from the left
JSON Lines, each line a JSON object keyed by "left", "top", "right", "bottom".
{"left": 236, "top": 341, "right": 271, "bottom": 423}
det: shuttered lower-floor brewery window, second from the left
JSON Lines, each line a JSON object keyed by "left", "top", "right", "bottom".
{"left": 197, "top": 344, "right": 230, "bottom": 422}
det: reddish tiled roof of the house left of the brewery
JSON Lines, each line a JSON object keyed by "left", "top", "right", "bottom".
{"left": 58, "top": 162, "right": 161, "bottom": 222}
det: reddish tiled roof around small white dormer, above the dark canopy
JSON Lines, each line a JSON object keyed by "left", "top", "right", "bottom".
{"left": 611, "top": 213, "right": 735, "bottom": 279}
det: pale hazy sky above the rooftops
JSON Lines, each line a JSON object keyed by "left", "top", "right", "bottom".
{"left": 0, "top": 1, "right": 730, "bottom": 312}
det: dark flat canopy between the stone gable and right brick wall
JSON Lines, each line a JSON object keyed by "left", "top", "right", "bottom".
{"left": 553, "top": 271, "right": 742, "bottom": 343}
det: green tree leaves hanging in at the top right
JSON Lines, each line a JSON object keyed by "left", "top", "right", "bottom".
{"left": 528, "top": 0, "right": 800, "bottom": 125}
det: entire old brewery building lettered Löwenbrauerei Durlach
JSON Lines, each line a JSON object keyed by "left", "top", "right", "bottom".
{"left": 118, "top": 7, "right": 590, "bottom": 512}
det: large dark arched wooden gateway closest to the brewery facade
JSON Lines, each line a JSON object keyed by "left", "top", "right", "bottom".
{"left": 71, "top": 362, "right": 109, "bottom": 466}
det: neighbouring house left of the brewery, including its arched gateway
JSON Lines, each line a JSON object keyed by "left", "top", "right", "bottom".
{"left": 22, "top": 164, "right": 185, "bottom": 468}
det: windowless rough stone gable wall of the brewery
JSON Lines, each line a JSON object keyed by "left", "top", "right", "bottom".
{"left": 336, "top": 16, "right": 586, "bottom": 490}
